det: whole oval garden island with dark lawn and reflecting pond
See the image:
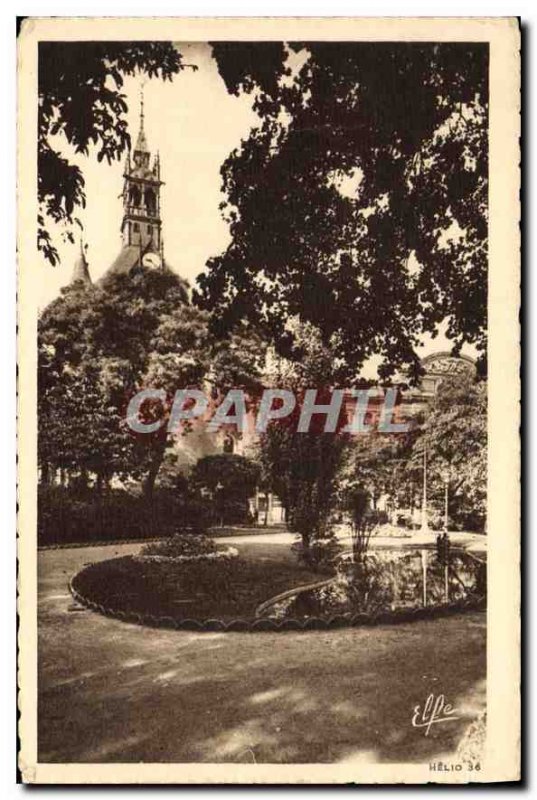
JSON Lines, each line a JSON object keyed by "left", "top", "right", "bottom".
{"left": 70, "top": 539, "right": 486, "bottom": 631}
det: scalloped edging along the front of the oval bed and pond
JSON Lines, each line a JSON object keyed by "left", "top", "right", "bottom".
{"left": 69, "top": 562, "right": 486, "bottom": 633}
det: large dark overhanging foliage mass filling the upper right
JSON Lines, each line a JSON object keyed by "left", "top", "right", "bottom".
{"left": 197, "top": 42, "right": 488, "bottom": 380}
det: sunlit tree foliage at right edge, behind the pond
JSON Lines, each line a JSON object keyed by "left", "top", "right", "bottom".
{"left": 340, "top": 376, "right": 487, "bottom": 530}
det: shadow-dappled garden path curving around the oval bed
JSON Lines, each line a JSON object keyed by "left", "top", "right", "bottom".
{"left": 39, "top": 537, "right": 486, "bottom": 763}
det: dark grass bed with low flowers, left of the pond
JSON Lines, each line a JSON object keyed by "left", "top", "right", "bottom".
{"left": 70, "top": 539, "right": 332, "bottom": 629}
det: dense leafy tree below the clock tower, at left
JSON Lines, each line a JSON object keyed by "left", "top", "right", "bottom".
{"left": 38, "top": 267, "right": 264, "bottom": 496}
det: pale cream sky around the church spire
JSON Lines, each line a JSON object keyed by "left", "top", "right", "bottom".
{"left": 39, "top": 43, "right": 476, "bottom": 371}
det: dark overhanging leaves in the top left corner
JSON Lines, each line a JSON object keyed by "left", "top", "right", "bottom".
{"left": 37, "top": 42, "right": 188, "bottom": 265}
